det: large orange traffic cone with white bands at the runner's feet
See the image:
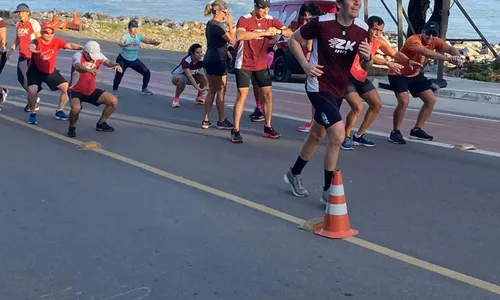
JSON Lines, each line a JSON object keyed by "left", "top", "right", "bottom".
{"left": 314, "top": 170, "right": 359, "bottom": 239}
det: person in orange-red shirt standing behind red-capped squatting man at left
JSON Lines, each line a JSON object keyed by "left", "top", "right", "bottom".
{"left": 7, "top": 3, "right": 41, "bottom": 112}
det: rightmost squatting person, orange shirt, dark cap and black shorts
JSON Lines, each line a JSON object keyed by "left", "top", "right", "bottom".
{"left": 388, "top": 21, "right": 463, "bottom": 144}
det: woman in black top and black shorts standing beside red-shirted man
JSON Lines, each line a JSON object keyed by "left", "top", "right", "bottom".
{"left": 201, "top": 0, "right": 234, "bottom": 129}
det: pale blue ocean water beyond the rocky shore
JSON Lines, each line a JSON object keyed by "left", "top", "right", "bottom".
{"left": 0, "top": 0, "right": 500, "bottom": 43}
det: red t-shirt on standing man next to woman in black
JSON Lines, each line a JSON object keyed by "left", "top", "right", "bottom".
{"left": 234, "top": 14, "right": 284, "bottom": 71}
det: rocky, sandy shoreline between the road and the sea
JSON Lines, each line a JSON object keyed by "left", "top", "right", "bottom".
{"left": 3, "top": 10, "right": 500, "bottom": 82}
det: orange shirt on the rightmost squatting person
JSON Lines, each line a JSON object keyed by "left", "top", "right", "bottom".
{"left": 389, "top": 34, "right": 447, "bottom": 77}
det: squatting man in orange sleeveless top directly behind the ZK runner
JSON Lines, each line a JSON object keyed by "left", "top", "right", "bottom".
{"left": 342, "top": 16, "right": 422, "bottom": 150}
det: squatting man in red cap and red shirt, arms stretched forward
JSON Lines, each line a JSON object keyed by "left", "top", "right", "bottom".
{"left": 27, "top": 22, "right": 83, "bottom": 124}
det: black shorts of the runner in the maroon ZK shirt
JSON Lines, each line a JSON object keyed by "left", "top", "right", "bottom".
{"left": 307, "top": 92, "right": 342, "bottom": 129}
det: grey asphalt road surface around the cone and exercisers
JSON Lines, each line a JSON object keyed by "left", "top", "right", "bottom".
{"left": 0, "top": 31, "right": 500, "bottom": 300}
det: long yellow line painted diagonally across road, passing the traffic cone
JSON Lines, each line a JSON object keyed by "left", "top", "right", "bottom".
{"left": 0, "top": 115, "right": 500, "bottom": 295}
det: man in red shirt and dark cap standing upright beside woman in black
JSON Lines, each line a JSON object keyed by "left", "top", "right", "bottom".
{"left": 231, "top": 0, "right": 292, "bottom": 143}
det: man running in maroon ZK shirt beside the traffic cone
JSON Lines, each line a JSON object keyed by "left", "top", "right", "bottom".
{"left": 284, "top": 0, "right": 373, "bottom": 203}
